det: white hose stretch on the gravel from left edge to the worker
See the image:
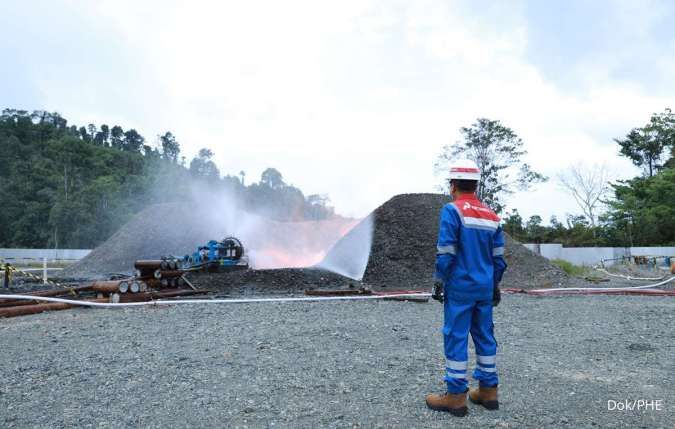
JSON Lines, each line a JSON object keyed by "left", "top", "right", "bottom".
{"left": 0, "top": 293, "right": 431, "bottom": 308}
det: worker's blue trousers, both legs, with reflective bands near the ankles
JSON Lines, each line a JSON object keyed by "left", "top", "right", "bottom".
{"left": 443, "top": 295, "right": 499, "bottom": 393}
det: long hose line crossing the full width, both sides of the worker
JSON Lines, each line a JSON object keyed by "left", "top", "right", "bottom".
{"left": 0, "top": 276, "right": 675, "bottom": 308}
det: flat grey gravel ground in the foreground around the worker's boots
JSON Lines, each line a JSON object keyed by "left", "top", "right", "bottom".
{"left": 0, "top": 295, "right": 675, "bottom": 428}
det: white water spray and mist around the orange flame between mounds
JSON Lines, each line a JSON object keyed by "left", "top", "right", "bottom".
{"left": 176, "top": 183, "right": 373, "bottom": 280}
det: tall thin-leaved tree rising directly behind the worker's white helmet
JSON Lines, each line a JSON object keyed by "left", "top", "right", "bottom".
{"left": 436, "top": 118, "right": 547, "bottom": 212}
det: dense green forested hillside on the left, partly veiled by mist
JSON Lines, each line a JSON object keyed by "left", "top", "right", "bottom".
{"left": 0, "top": 109, "right": 335, "bottom": 248}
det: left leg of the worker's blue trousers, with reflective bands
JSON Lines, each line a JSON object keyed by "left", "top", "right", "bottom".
{"left": 443, "top": 299, "right": 473, "bottom": 393}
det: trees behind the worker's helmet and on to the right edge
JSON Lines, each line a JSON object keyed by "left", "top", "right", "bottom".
{"left": 436, "top": 108, "right": 675, "bottom": 247}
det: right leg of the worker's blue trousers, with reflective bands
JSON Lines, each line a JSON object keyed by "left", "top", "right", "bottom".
{"left": 471, "top": 301, "right": 499, "bottom": 387}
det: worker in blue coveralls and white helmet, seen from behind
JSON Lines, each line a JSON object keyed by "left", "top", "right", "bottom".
{"left": 426, "top": 160, "right": 506, "bottom": 417}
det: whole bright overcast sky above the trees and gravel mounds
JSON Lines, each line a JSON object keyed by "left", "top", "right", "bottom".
{"left": 0, "top": 0, "right": 675, "bottom": 219}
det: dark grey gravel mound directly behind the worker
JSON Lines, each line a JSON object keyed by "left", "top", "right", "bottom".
{"left": 322, "top": 194, "right": 576, "bottom": 289}
